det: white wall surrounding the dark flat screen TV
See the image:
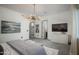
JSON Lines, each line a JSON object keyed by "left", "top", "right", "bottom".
{"left": 48, "top": 11, "right": 72, "bottom": 44}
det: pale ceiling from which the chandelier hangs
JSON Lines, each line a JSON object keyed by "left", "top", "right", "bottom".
{"left": 0, "top": 4, "right": 71, "bottom": 16}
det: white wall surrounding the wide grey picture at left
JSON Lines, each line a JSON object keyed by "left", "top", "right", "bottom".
{"left": 0, "top": 7, "right": 29, "bottom": 42}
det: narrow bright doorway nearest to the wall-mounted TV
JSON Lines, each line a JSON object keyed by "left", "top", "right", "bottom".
{"left": 41, "top": 20, "right": 48, "bottom": 39}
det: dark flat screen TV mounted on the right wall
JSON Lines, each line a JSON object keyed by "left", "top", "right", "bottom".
{"left": 52, "top": 23, "right": 68, "bottom": 32}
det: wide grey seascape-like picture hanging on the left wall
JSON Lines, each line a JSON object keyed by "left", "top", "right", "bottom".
{"left": 1, "top": 21, "right": 21, "bottom": 34}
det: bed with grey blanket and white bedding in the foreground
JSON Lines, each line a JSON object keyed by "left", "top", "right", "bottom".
{"left": 1, "top": 40, "right": 58, "bottom": 55}
